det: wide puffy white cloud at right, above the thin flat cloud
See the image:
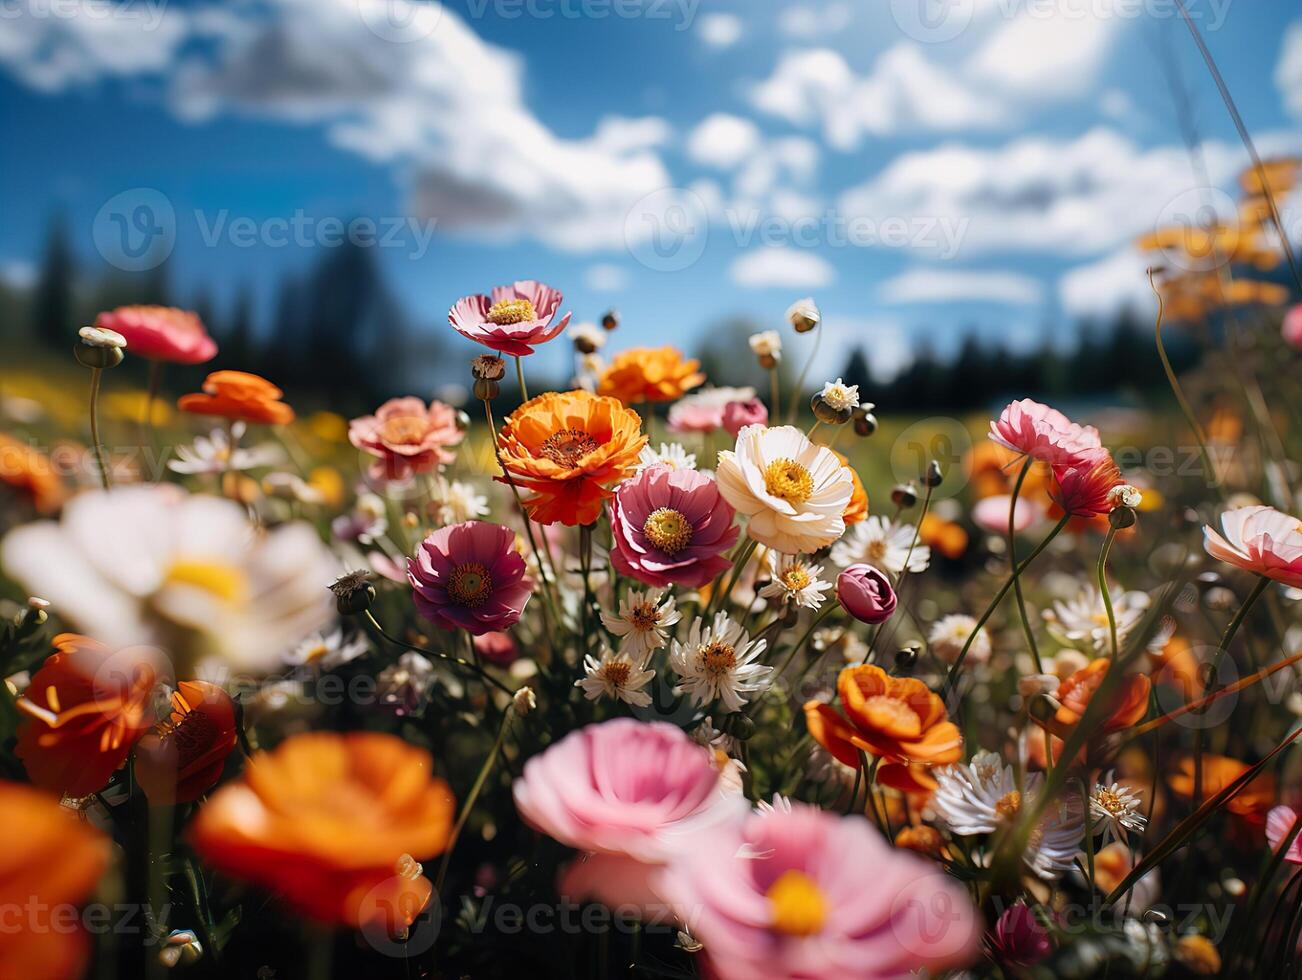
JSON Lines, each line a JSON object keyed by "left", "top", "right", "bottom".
{"left": 840, "top": 128, "right": 1242, "bottom": 255}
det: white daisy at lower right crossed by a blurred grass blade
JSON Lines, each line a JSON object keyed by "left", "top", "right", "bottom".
{"left": 927, "top": 752, "right": 1085, "bottom": 878}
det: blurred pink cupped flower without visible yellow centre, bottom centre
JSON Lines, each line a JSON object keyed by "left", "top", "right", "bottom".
{"left": 514, "top": 718, "right": 747, "bottom": 908}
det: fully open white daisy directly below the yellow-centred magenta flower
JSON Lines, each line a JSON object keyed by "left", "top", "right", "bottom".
{"left": 669, "top": 613, "right": 773, "bottom": 712}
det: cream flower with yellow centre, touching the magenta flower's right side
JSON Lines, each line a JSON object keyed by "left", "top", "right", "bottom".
{"left": 716, "top": 426, "right": 854, "bottom": 554}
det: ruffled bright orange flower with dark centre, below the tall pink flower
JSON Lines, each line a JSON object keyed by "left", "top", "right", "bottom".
{"left": 499, "top": 390, "right": 647, "bottom": 526}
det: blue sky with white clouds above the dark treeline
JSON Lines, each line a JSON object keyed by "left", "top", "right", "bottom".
{"left": 0, "top": 0, "right": 1302, "bottom": 382}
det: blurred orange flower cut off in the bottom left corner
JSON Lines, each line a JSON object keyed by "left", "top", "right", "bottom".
{"left": 0, "top": 782, "right": 109, "bottom": 980}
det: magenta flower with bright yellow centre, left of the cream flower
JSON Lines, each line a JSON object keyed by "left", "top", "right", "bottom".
{"left": 609, "top": 463, "right": 738, "bottom": 588}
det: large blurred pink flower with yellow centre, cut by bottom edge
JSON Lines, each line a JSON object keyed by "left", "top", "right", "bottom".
{"left": 655, "top": 804, "right": 980, "bottom": 980}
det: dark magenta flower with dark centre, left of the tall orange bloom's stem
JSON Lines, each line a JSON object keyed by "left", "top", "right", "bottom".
{"left": 408, "top": 521, "right": 534, "bottom": 636}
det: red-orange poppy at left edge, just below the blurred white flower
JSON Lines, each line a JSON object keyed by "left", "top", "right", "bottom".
{"left": 14, "top": 633, "right": 161, "bottom": 796}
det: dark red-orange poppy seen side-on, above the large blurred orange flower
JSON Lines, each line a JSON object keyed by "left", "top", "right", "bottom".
{"left": 134, "top": 681, "right": 236, "bottom": 804}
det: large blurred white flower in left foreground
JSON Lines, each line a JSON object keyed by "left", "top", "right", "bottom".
{"left": 0, "top": 485, "right": 340, "bottom": 672}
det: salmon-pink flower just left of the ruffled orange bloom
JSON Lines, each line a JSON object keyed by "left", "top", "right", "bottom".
{"left": 348, "top": 397, "right": 462, "bottom": 480}
